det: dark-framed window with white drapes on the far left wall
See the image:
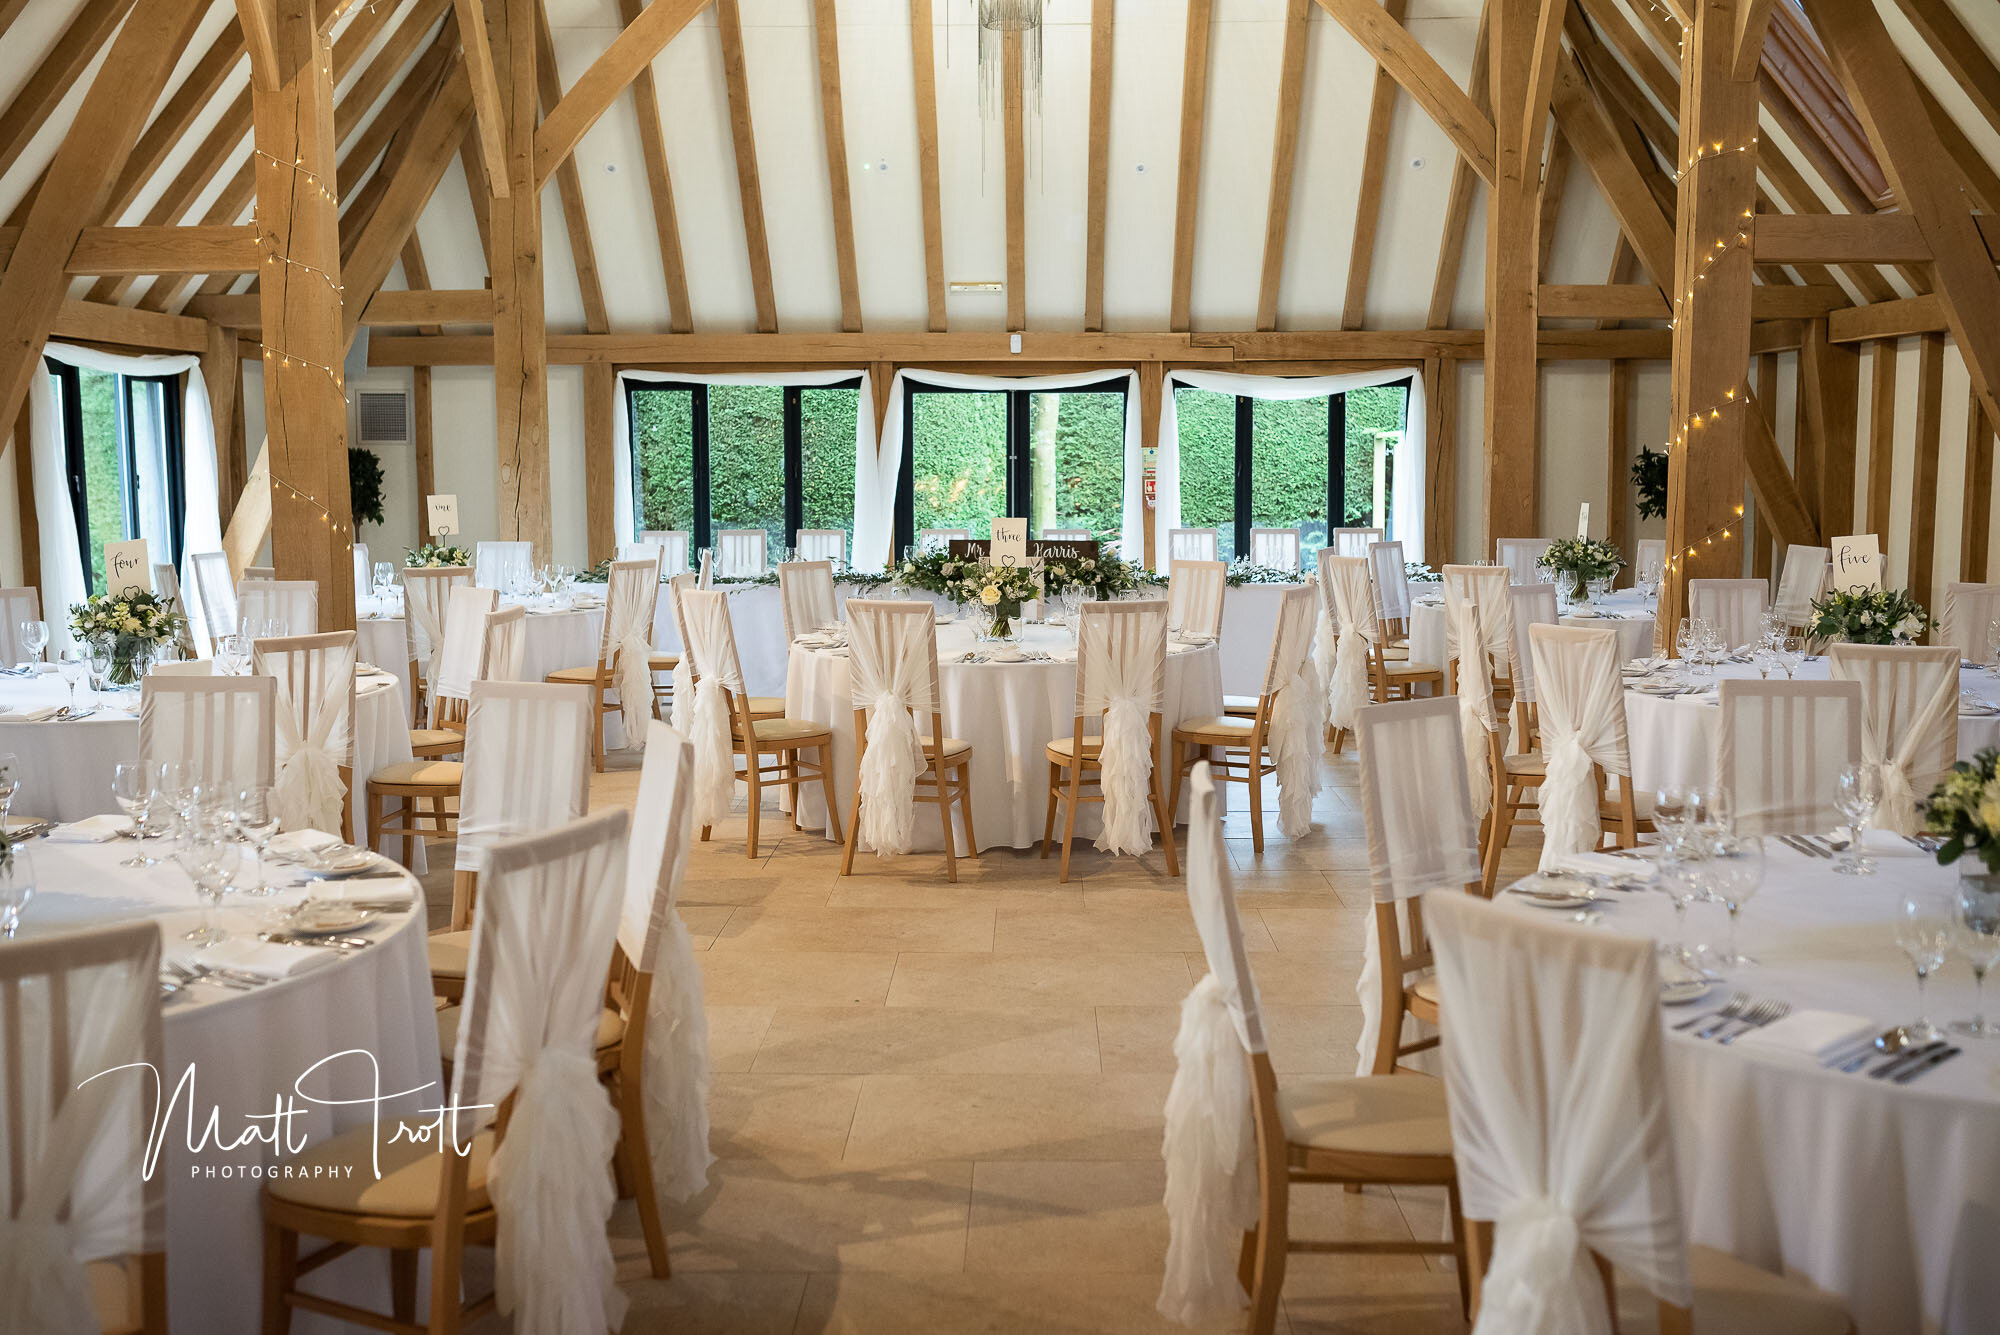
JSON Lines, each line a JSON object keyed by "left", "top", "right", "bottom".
{"left": 44, "top": 360, "right": 186, "bottom": 594}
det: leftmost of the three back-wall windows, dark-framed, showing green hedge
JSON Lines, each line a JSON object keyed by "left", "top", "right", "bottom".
{"left": 626, "top": 380, "right": 862, "bottom": 562}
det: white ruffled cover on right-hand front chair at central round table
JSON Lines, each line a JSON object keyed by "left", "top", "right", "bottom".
{"left": 1076, "top": 600, "right": 1166, "bottom": 855}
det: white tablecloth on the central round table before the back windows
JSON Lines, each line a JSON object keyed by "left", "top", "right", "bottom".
{"left": 784, "top": 624, "right": 1222, "bottom": 849}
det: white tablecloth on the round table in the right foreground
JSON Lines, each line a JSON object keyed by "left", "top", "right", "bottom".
{"left": 1500, "top": 833, "right": 2000, "bottom": 1335}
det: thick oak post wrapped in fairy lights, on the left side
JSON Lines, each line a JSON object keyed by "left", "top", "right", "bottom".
{"left": 250, "top": 0, "right": 354, "bottom": 630}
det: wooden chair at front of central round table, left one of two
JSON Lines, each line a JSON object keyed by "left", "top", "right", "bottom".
{"left": 836, "top": 599, "right": 980, "bottom": 885}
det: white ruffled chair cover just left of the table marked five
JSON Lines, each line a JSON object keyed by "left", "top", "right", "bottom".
{"left": 1528, "top": 626, "right": 1632, "bottom": 871}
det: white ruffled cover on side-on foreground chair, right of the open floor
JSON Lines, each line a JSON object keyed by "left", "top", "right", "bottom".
{"left": 1156, "top": 761, "right": 1264, "bottom": 1325}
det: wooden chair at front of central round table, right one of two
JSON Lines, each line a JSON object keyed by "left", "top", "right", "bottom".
{"left": 1042, "top": 602, "right": 1180, "bottom": 883}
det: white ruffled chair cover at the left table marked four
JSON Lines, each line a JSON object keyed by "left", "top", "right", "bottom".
{"left": 254, "top": 630, "right": 356, "bottom": 833}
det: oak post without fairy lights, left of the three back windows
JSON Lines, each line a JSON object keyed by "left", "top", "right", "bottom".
{"left": 486, "top": 0, "right": 550, "bottom": 562}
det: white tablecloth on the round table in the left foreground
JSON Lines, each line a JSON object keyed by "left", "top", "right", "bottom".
{"left": 17, "top": 839, "right": 440, "bottom": 1335}
